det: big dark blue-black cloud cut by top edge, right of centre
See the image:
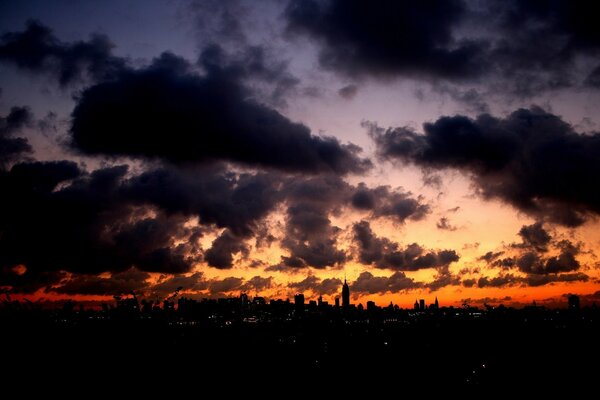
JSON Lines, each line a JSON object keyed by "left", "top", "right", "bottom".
{"left": 286, "top": 0, "right": 485, "bottom": 80}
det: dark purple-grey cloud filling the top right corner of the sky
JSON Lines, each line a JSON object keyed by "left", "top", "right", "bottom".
{"left": 489, "top": 0, "right": 600, "bottom": 94}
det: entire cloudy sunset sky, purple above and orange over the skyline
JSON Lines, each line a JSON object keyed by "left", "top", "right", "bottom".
{"left": 0, "top": 0, "right": 600, "bottom": 307}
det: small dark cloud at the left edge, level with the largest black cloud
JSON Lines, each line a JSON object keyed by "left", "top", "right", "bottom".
{"left": 0, "top": 107, "right": 33, "bottom": 168}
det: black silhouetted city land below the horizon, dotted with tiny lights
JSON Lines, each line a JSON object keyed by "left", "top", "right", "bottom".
{"left": 1, "top": 299, "right": 600, "bottom": 393}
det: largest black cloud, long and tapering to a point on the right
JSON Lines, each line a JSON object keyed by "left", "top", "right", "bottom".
{"left": 71, "top": 51, "right": 371, "bottom": 174}
